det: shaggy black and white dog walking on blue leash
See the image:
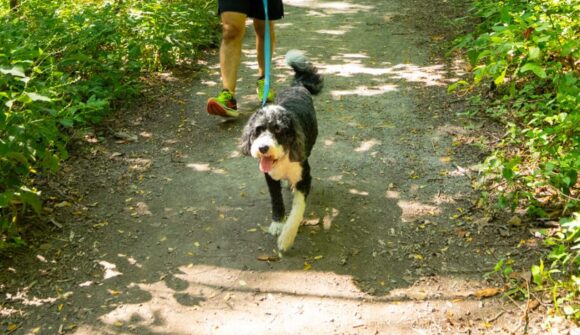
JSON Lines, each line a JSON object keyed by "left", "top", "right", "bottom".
{"left": 240, "top": 50, "right": 323, "bottom": 251}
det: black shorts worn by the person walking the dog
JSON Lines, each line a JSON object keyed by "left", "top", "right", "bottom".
{"left": 218, "top": 0, "right": 284, "bottom": 20}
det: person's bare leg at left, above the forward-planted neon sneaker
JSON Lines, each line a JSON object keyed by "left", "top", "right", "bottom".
{"left": 220, "top": 12, "right": 246, "bottom": 95}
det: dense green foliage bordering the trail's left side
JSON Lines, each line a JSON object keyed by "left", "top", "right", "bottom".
{"left": 0, "top": 0, "right": 219, "bottom": 247}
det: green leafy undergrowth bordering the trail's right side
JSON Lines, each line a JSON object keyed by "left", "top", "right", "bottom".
{"left": 456, "top": 0, "right": 580, "bottom": 318}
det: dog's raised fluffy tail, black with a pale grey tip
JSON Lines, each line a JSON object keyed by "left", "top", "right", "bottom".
{"left": 286, "top": 50, "right": 324, "bottom": 94}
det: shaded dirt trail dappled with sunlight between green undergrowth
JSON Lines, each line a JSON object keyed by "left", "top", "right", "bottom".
{"left": 0, "top": 0, "right": 552, "bottom": 335}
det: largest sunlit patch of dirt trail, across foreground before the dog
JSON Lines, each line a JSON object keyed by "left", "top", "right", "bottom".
{"left": 65, "top": 264, "right": 494, "bottom": 335}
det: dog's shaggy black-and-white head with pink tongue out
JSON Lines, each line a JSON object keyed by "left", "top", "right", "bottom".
{"left": 240, "top": 105, "right": 306, "bottom": 173}
